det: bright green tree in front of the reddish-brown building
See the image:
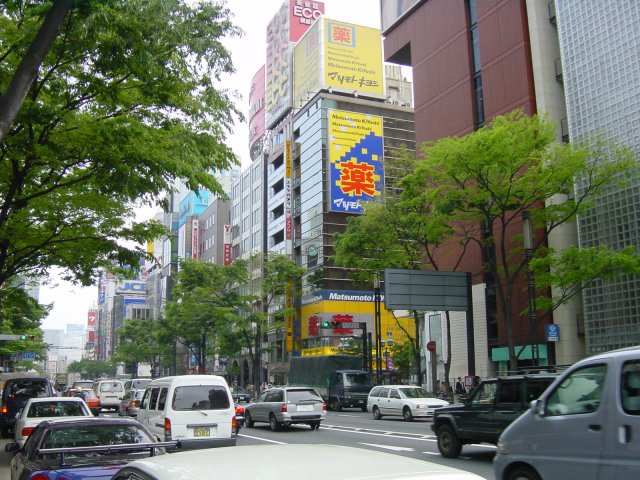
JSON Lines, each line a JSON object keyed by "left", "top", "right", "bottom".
{"left": 402, "top": 111, "right": 639, "bottom": 369}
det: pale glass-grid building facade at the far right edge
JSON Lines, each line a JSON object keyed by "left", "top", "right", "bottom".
{"left": 556, "top": 0, "right": 640, "bottom": 353}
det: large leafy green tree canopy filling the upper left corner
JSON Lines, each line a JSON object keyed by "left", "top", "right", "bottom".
{"left": 0, "top": 0, "right": 241, "bottom": 308}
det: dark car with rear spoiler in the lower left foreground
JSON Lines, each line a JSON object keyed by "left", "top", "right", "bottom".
{"left": 5, "top": 417, "right": 176, "bottom": 480}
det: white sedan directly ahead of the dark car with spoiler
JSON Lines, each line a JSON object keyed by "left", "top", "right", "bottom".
{"left": 14, "top": 397, "right": 93, "bottom": 448}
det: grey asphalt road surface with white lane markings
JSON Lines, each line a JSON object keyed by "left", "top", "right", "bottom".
{"left": 0, "top": 409, "right": 495, "bottom": 480}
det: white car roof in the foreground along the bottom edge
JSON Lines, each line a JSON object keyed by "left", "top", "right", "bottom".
{"left": 111, "top": 444, "right": 482, "bottom": 480}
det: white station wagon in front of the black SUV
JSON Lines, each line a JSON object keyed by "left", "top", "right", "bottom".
{"left": 367, "top": 385, "right": 449, "bottom": 421}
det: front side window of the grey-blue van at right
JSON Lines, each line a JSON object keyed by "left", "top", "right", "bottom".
{"left": 546, "top": 365, "right": 607, "bottom": 416}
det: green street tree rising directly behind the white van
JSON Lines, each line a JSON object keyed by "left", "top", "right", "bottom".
{"left": 165, "top": 260, "right": 249, "bottom": 373}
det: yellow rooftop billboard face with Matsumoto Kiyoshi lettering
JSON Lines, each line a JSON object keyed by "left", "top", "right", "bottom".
{"left": 324, "top": 19, "right": 384, "bottom": 96}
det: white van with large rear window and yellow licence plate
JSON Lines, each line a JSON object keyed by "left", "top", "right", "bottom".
{"left": 138, "top": 375, "right": 236, "bottom": 449}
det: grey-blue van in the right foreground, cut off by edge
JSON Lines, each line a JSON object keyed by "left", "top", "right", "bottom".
{"left": 494, "top": 346, "right": 640, "bottom": 480}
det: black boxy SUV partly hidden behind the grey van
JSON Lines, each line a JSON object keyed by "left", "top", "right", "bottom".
{"left": 431, "top": 373, "right": 557, "bottom": 458}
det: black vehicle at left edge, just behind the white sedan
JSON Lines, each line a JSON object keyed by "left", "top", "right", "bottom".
{"left": 0, "top": 377, "right": 53, "bottom": 438}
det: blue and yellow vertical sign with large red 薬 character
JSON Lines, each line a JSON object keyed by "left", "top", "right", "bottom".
{"left": 327, "top": 110, "right": 384, "bottom": 213}
